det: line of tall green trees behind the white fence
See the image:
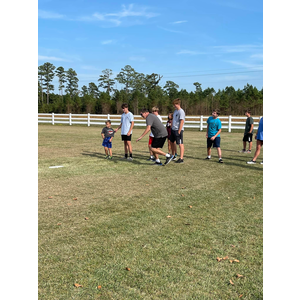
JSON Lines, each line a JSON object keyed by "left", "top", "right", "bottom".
{"left": 38, "top": 62, "right": 263, "bottom": 115}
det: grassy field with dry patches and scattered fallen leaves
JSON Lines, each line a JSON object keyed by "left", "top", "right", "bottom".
{"left": 38, "top": 125, "right": 263, "bottom": 300}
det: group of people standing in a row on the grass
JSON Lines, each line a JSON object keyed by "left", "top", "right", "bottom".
{"left": 101, "top": 98, "right": 263, "bottom": 166}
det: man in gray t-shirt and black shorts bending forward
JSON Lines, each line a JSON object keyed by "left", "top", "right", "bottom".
{"left": 136, "top": 109, "right": 173, "bottom": 166}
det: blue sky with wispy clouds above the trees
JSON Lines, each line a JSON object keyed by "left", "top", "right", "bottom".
{"left": 38, "top": 0, "right": 263, "bottom": 93}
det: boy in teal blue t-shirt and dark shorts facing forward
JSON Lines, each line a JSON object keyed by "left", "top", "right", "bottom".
{"left": 206, "top": 109, "right": 223, "bottom": 163}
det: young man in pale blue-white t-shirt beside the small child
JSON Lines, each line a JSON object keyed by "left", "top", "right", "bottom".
{"left": 115, "top": 103, "right": 134, "bottom": 161}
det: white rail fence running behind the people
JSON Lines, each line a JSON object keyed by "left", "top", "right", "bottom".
{"left": 38, "top": 113, "right": 261, "bottom": 132}
